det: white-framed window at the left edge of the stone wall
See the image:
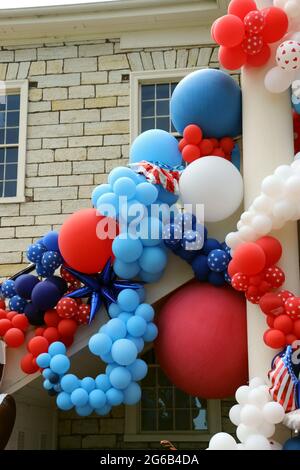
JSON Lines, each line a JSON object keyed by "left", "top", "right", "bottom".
{"left": 0, "top": 81, "right": 28, "bottom": 203}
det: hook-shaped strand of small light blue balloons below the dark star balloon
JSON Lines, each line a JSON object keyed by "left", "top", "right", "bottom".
{"left": 36, "top": 289, "right": 157, "bottom": 416}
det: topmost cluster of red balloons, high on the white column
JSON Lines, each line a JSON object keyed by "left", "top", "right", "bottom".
{"left": 211, "top": 0, "right": 288, "bottom": 70}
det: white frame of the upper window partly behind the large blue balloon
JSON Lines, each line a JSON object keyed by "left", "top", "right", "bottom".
{"left": 130, "top": 68, "right": 198, "bottom": 142}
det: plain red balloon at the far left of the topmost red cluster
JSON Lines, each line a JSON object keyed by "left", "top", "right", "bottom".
{"left": 213, "top": 15, "right": 245, "bottom": 47}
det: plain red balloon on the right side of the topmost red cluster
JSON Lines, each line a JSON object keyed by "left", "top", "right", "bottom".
{"left": 261, "top": 7, "right": 289, "bottom": 43}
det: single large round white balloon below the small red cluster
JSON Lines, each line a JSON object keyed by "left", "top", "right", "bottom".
{"left": 179, "top": 157, "right": 243, "bottom": 222}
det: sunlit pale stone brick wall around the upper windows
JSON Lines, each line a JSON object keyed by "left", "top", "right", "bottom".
{"left": 0, "top": 39, "right": 227, "bottom": 278}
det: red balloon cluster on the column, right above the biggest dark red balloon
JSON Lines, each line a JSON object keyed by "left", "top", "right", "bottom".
{"left": 228, "top": 236, "right": 285, "bottom": 304}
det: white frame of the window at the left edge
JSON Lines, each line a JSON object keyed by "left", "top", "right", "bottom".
{"left": 0, "top": 80, "right": 29, "bottom": 204}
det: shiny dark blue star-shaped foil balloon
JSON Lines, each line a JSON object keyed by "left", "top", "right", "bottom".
{"left": 65, "top": 259, "right": 143, "bottom": 323}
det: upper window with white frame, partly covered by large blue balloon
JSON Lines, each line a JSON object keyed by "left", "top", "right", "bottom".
{"left": 131, "top": 69, "right": 191, "bottom": 141}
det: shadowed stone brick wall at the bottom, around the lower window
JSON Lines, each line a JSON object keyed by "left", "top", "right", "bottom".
{"left": 57, "top": 399, "right": 236, "bottom": 450}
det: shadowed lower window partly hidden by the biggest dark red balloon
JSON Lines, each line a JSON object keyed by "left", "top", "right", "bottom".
{"left": 125, "top": 349, "right": 221, "bottom": 441}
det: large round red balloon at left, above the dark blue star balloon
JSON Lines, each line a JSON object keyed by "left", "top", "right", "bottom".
{"left": 58, "top": 209, "right": 118, "bottom": 274}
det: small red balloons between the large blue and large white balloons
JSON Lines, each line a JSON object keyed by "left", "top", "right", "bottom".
{"left": 179, "top": 124, "right": 235, "bottom": 163}
